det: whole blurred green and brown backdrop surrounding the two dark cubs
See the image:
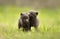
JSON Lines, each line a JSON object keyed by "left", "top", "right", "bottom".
{"left": 0, "top": 0, "right": 60, "bottom": 39}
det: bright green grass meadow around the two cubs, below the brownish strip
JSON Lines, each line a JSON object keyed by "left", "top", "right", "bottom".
{"left": 0, "top": 6, "right": 60, "bottom": 39}
